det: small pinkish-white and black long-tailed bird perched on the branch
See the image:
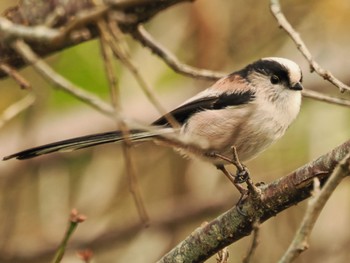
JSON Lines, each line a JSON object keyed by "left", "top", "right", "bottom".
{"left": 4, "top": 57, "right": 302, "bottom": 173}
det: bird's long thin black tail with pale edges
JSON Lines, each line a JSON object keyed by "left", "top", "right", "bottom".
{"left": 3, "top": 129, "right": 171, "bottom": 160}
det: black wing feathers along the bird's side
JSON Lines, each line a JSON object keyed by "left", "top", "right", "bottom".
{"left": 152, "top": 91, "right": 255, "bottom": 126}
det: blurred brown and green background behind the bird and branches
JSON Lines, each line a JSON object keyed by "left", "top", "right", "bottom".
{"left": 0, "top": 0, "right": 350, "bottom": 263}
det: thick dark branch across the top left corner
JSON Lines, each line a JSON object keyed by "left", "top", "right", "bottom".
{"left": 0, "top": 0, "right": 193, "bottom": 78}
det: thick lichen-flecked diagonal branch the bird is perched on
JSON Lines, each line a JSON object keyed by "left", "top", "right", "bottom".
{"left": 159, "top": 141, "right": 350, "bottom": 263}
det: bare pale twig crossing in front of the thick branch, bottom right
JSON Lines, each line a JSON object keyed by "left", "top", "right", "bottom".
{"left": 279, "top": 153, "right": 350, "bottom": 263}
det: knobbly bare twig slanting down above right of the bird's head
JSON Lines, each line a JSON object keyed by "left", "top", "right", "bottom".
{"left": 270, "top": 0, "right": 350, "bottom": 92}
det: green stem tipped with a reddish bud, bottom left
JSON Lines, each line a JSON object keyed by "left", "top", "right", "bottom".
{"left": 52, "top": 209, "right": 86, "bottom": 263}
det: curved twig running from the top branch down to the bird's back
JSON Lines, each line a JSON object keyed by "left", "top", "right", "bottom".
{"left": 130, "top": 24, "right": 224, "bottom": 80}
